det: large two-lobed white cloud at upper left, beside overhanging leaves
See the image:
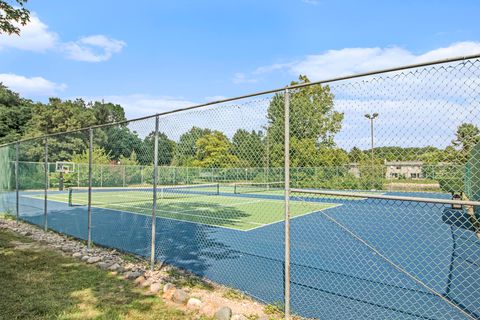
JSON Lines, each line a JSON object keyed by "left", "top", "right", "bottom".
{"left": 0, "top": 12, "right": 126, "bottom": 62}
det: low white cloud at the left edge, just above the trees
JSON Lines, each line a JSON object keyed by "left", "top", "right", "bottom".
{"left": 0, "top": 73, "right": 67, "bottom": 96}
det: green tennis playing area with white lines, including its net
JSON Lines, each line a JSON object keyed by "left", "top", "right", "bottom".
{"left": 26, "top": 184, "right": 339, "bottom": 231}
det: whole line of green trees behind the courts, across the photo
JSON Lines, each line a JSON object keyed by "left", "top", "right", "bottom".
{"left": 0, "top": 76, "right": 480, "bottom": 168}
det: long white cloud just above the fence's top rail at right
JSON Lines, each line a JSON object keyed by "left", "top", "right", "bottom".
{"left": 251, "top": 41, "right": 480, "bottom": 80}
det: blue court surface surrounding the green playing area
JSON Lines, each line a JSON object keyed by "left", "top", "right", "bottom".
{"left": 4, "top": 192, "right": 480, "bottom": 319}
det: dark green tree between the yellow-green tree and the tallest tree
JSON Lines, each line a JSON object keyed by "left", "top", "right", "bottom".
{"left": 232, "top": 129, "right": 266, "bottom": 167}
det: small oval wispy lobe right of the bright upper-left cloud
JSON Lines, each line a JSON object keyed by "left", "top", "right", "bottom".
{"left": 63, "top": 35, "right": 125, "bottom": 62}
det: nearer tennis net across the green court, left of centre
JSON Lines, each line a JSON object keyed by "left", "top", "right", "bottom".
{"left": 68, "top": 183, "right": 220, "bottom": 206}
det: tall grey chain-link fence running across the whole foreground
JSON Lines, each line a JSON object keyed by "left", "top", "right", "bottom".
{"left": 0, "top": 57, "right": 480, "bottom": 319}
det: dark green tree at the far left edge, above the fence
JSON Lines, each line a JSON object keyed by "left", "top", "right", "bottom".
{"left": 0, "top": 83, "right": 33, "bottom": 143}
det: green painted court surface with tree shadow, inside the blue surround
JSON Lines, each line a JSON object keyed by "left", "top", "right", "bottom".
{"left": 31, "top": 188, "right": 338, "bottom": 231}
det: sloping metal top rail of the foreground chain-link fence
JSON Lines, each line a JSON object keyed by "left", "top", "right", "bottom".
{"left": 0, "top": 53, "right": 480, "bottom": 147}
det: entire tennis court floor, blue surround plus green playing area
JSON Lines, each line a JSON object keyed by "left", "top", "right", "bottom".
{"left": 16, "top": 185, "right": 478, "bottom": 319}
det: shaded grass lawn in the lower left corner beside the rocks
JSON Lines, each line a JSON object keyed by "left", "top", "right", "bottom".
{"left": 0, "top": 229, "right": 201, "bottom": 320}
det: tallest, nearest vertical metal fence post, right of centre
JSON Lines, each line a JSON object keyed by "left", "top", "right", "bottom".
{"left": 284, "top": 89, "right": 290, "bottom": 320}
